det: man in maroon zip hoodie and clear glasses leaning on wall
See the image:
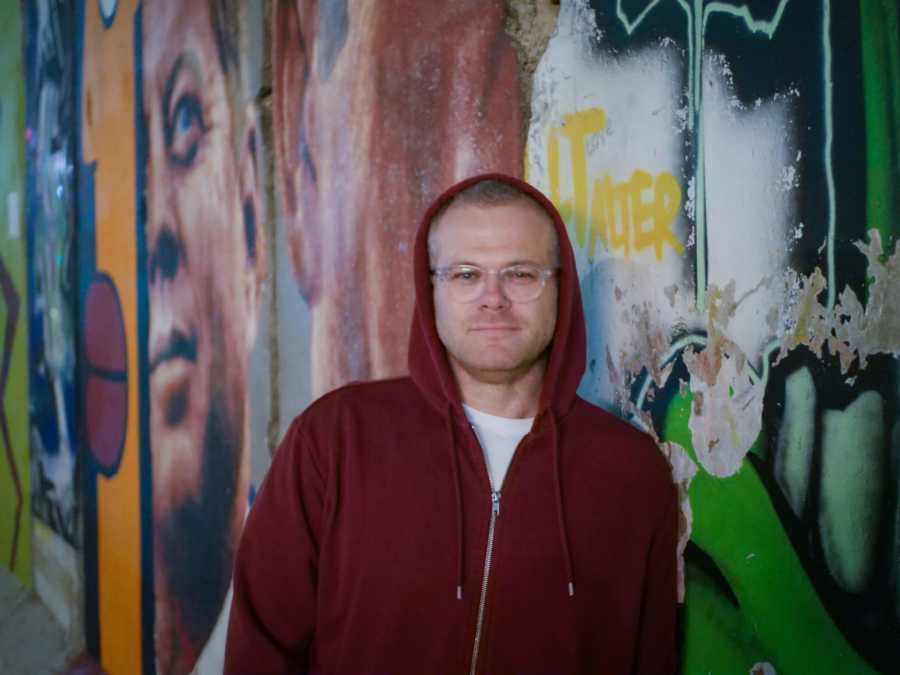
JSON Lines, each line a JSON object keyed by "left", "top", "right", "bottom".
{"left": 225, "top": 174, "right": 678, "bottom": 673}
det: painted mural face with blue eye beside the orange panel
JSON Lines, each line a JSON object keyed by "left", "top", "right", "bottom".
{"left": 142, "top": 1, "right": 266, "bottom": 673}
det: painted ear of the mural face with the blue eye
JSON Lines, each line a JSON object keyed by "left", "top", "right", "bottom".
{"left": 238, "top": 103, "right": 268, "bottom": 351}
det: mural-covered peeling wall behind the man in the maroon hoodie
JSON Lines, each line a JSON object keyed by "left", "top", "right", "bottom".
{"left": 0, "top": 0, "right": 900, "bottom": 673}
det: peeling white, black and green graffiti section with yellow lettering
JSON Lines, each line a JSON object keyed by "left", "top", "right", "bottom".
{"left": 527, "top": 0, "right": 900, "bottom": 673}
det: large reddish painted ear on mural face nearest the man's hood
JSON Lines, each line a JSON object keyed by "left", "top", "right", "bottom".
{"left": 272, "top": 0, "right": 321, "bottom": 303}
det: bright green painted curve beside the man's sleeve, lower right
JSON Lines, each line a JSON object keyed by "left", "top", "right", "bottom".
{"left": 663, "top": 393, "right": 875, "bottom": 675}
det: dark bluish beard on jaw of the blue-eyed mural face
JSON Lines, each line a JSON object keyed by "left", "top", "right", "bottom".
{"left": 155, "top": 390, "right": 244, "bottom": 672}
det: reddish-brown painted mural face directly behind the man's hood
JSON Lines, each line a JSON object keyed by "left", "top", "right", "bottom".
{"left": 272, "top": 0, "right": 522, "bottom": 402}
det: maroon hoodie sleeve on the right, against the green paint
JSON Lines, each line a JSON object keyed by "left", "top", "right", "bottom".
{"left": 635, "top": 486, "right": 679, "bottom": 675}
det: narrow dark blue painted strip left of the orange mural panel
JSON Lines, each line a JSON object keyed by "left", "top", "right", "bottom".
{"left": 24, "top": 0, "right": 80, "bottom": 546}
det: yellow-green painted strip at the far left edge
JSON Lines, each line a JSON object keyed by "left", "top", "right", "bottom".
{"left": 0, "top": 2, "right": 31, "bottom": 585}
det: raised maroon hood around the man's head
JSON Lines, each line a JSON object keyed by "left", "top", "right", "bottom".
{"left": 409, "top": 173, "right": 586, "bottom": 419}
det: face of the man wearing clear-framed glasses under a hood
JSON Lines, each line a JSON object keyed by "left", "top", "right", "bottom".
{"left": 431, "top": 197, "right": 557, "bottom": 382}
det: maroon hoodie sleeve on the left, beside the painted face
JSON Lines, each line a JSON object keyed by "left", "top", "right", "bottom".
{"left": 224, "top": 419, "right": 325, "bottom": 673}
